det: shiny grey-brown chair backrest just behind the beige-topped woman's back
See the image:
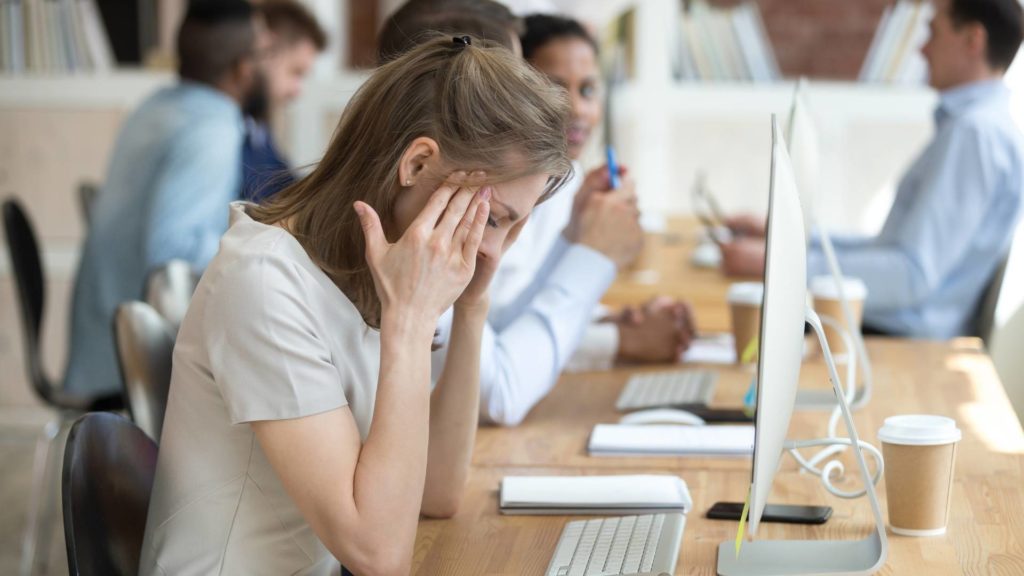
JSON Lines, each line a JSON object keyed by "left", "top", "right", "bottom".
{"left": 114, "top": 302, "right": 175, "bottom": 444}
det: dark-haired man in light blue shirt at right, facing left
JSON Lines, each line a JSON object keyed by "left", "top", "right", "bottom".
{"left": 723, "top": 0, "right": 1024, "bottom": 338}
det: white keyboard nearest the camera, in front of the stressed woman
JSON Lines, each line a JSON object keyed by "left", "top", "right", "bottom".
{"left": 546, "top": 512, "right": 686, "bottom": 576}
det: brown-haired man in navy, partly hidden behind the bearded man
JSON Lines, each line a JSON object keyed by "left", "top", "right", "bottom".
{"left": 242, "top": 0, "right": 327, "bottom": 202}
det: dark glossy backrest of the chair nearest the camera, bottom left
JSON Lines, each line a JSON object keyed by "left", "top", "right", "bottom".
{"left": 60, "top": 412, "right": 157, "bottom": 576}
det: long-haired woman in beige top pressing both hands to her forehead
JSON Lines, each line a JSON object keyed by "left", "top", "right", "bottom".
{"left": 140, "top": 36, "right": 570, "bottom": 576}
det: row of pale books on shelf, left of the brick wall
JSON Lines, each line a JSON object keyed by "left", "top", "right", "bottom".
{"left": 676, "top": 0, "right": 781, "bottom": 82}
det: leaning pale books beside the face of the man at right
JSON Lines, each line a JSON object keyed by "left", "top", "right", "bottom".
{"left": 860, "top": 0, "right": 934, "bottom": 84}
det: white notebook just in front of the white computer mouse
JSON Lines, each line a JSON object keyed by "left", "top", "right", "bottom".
{"left": 588, "top": 424, "right": 754, "bottom": 457}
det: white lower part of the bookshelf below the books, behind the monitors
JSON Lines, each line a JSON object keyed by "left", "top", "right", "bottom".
{"left": 610, "top": 82, "right": 937, "bottom": 233}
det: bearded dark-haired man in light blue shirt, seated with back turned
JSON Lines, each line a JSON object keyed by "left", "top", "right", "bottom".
{"left": 65, "top": 0, "right": 265, "bottom": 393}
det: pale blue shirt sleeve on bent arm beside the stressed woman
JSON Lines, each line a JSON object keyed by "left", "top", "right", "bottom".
{"left": 480, "top": 239, "right": 615, "bottom": 425}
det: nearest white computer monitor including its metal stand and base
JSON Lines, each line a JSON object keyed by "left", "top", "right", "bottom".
{"left": 718, "top": 116, "right": 888, "bottom": 576}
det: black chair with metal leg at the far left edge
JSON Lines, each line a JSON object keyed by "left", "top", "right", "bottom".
{"left": 3, "top": 199, "right": 124, "bottom": 573}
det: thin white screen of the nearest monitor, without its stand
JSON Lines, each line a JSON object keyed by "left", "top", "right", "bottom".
{"left": 750, "top": 117, "right": 807, "bottom": 535}
